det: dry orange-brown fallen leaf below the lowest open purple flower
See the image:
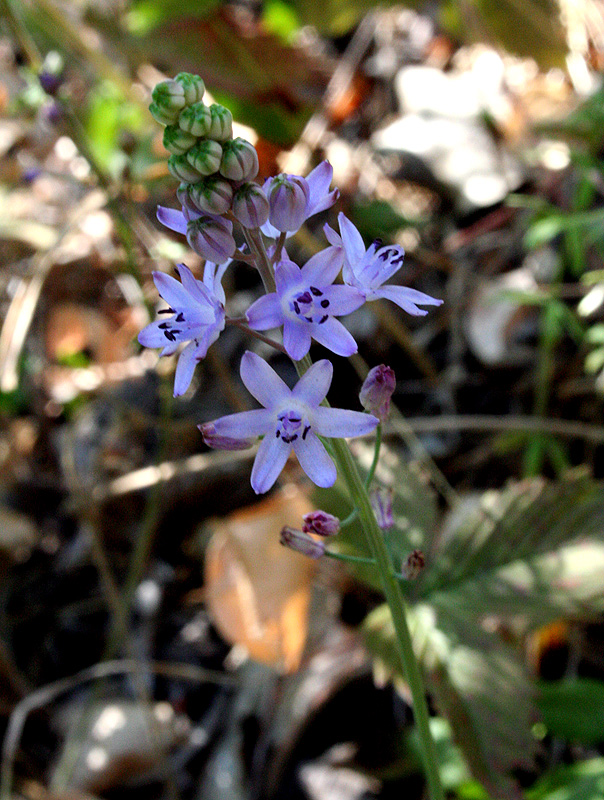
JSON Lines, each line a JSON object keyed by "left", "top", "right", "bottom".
{"left": 205, "top": 485, "right": 316, "bottom": 672}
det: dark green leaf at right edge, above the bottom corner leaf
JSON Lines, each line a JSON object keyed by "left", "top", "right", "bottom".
{"left": 537, "top": 678, "right": 604, "bottom": 744}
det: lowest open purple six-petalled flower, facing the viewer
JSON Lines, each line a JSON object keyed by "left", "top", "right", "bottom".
{"left": 199, "top": 350, "right": 378, "bottom": 494}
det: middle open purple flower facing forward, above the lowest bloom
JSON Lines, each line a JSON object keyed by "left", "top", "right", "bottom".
{"left": 246, "top": 247, "right": 365, "bottom": 361}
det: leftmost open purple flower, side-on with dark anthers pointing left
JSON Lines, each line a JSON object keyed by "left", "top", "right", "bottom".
{"left": 138, "top": 262, "right": 229, "bottom": 397}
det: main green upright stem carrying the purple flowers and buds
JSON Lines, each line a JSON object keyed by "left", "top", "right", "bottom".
{"left": 246, "top": 230, "right": 445, "bottom": 800}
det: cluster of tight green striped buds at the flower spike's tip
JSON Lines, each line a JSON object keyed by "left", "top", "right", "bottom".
{"left": 149, "top": 72, "right": 268, "bottom": 224}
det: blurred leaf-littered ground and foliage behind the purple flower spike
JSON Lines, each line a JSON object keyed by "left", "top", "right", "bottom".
{"left": 0, "top": 0, "right": 604, "bottom": 800}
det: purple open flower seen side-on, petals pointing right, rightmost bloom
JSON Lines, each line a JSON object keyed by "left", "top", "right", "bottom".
{"left": 324, "top": 212, "right": 443, "bottom": 317}
